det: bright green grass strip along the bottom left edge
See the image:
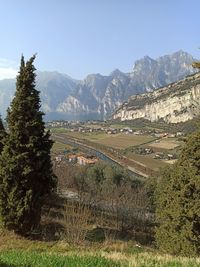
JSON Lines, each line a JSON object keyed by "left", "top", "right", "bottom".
{"left": 0, "top": 251, "right": 122, "bottom": 267}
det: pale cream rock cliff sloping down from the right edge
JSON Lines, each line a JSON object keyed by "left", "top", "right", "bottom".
{"left": 113, "top": 72, "right": 200, "bottom": 123}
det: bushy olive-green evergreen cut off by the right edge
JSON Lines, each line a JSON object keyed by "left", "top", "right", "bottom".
{"left": 156, "top": 132, "right": 200, "bottom": 256}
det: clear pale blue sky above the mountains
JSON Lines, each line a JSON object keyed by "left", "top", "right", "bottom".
{"left": 0, "top": 0, "right": 200, "bottom": 79}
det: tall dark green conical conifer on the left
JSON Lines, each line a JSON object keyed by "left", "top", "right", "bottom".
{"left": 0, "top": 55, "right": 56, "bottom": 234}
